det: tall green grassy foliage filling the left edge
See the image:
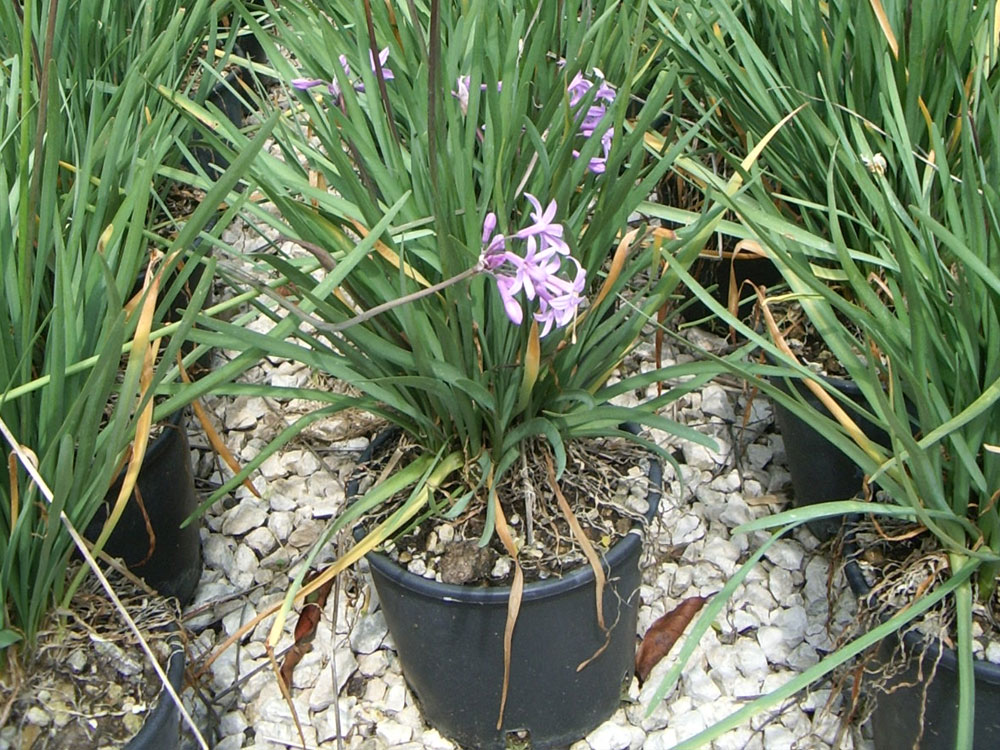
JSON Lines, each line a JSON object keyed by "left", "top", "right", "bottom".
{"left": 0, "top": 0, "right": 274, "bottom": 744}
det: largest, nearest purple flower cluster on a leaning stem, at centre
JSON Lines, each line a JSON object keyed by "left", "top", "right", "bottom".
{"left": 479, "top": 193, "right": 587, "bottom": 336}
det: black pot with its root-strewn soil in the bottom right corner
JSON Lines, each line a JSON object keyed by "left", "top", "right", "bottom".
{"left": 845, "top": 530, "right": 1000, "bottom": 750}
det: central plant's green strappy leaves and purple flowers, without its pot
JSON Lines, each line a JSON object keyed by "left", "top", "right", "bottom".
{"left": 176, "top": 0, "right": 714, "bottom": 684}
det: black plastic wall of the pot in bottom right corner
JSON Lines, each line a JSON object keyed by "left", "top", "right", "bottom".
{"left": 844, "top": 561, "right": 1000, "bottom": 750}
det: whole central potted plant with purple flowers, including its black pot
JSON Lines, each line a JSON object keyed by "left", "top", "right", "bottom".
{"left": 172, "top": 0, "right": 752, "bottom": 747}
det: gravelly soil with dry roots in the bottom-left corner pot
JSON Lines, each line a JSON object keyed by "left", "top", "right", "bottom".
{"left": 0, "top": 572, "right": 184, "bottom": 750}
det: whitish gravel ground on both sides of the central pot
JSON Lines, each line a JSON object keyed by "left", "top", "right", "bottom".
{"left": 178, "top": 222, "right": 868, "bottom": 750}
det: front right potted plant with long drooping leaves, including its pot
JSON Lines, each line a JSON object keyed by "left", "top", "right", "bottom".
{"left": 636, "top": 2, "right": 1000, "bottom": 748}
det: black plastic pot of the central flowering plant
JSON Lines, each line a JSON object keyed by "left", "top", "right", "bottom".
{"left": 348, "top": 434, "right": 661, "bottom": 750}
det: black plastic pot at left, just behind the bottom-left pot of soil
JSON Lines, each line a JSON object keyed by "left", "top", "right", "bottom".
{"left": 86, "top": 411, "right": 203, "bottom": 604}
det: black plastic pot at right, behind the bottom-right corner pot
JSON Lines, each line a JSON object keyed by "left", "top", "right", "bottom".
{"left": 771, "top": 370, "right": 889, "bottom": 540}
